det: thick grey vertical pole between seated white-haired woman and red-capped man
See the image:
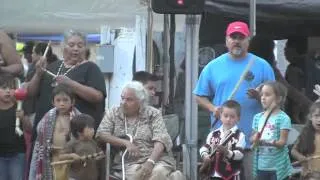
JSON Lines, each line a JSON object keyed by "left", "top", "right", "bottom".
{"left": 183, "top": 15, "right": 200, "bottom": 180}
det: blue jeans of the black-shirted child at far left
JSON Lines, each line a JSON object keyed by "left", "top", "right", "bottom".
{"left": 0, "top": 153, "right": 25, "bottom": 180}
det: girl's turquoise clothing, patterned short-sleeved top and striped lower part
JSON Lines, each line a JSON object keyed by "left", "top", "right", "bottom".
{"left": 252, "top": 111, "right": 291, "bottom": 179}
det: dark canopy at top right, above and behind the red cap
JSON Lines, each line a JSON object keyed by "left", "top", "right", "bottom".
{"left": 200, "top": 0, "right": 320, "bottom": 45}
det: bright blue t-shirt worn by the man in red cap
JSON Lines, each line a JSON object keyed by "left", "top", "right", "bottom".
{"left": 193, "top": 53, "right": 275, "bottom": 147}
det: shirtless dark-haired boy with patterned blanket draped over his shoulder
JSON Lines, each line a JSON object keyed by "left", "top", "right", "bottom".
{"left": 29, "top": 84, "right": 80, "bottom": 180}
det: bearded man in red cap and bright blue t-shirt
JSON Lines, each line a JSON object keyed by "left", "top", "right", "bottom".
{"left": 193, "top": 21, "right": 275, "bottom": 180}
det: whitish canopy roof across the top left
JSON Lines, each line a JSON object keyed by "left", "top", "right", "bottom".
{"left": 0, "top": 0, "right": 184, "bottom": 34}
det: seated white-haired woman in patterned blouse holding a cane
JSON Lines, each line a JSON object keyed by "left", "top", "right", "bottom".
{"left": 97, "top": 81, "right": 183, "bottom": 180}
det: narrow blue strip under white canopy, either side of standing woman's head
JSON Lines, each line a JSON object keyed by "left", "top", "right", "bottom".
{"left": 17, "top": 34, "right": 100, "bottom": 44}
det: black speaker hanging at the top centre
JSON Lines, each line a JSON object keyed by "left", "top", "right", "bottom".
{"left": 151, "top": 0, "right": 204, "bottom": 14}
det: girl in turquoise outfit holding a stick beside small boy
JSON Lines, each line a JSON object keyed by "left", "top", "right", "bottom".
{"left": 251, "top": 81, "right": 292, "bottom": 180}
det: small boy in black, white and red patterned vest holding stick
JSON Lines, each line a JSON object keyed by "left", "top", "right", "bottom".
{"left": 200, "top": 100, "right": 246, "bottom": 180}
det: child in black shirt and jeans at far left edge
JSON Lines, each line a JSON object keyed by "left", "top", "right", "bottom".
{"left": 0, "top": 73, "right": 31, "bottom": 180}
